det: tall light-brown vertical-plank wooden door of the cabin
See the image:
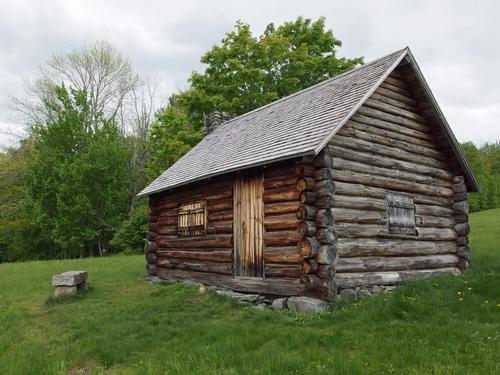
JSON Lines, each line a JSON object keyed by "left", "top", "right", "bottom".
{"left": 233, "top": 173, "right": 264, "bottom": 277}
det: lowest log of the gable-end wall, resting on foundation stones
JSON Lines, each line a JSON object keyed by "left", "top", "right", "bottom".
{"left": 335, "top": 267, "right": 460, "bottom": 288}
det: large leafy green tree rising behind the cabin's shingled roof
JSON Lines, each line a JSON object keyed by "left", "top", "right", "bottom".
{"left": 177, "top": 17, "right": 363, "bottom": 126}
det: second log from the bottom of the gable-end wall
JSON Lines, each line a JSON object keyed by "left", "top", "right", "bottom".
{"left": 335, "top": 254, "right": 458, "bottom": 274}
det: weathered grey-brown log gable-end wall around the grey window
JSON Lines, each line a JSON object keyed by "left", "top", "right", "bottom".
{"left": 328, "top": 70, "right": 462, "bottom": 288}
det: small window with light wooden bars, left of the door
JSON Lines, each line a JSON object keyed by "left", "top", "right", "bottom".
{"left": 177, "top": 201, "right": 207, "bottom": 237}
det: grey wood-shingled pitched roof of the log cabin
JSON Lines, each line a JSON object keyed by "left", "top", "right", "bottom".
{"left": 139, "top": 48, "right": 479, "bottom": 196}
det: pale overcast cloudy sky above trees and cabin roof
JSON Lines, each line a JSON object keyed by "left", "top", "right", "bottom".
{"left": 0, "top": 0, "right": 500, "bottom": 150}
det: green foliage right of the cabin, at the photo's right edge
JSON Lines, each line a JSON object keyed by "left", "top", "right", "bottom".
{"left": 461, "top": 141, "right": 500, "bottom": 211}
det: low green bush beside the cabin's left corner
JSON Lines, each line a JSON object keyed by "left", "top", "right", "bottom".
{"left": 110, "top": 199, "right": 148, "bottom": 254}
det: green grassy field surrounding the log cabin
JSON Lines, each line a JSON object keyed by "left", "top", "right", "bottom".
{"left": 0, "top": 210, "right": 500, "bottom": 375}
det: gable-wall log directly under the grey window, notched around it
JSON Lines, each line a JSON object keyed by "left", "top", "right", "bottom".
{"left": 333, "top": 224, "right": 457, "bottom": 241}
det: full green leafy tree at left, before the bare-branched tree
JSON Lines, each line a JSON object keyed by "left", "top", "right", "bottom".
{"left": 26, "top": 86, "right": 129, "bottom": 257}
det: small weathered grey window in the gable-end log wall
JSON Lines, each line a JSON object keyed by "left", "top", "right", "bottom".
{"left": 386, "top": 193, "right": 417, "bottom": 236}
